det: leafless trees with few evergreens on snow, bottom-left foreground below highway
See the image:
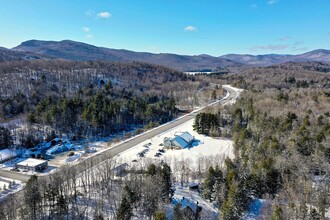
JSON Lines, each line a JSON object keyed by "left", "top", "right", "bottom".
{"left": 0, "top": 159, "right": 174, "bottom": 220}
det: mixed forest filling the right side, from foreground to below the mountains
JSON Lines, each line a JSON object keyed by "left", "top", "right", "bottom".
{"left": 204, "top": 63, "right": 330, "bottom": 219}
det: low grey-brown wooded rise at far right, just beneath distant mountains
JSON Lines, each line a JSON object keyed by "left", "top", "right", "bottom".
{"left": 219, "top": 62, "right": 330, "bottom": 92}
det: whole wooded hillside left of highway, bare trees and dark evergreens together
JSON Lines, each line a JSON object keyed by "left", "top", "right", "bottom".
{"left": 0, "top": 60, "right": 221, "bottom": 147}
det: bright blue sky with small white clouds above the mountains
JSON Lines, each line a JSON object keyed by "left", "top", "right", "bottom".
{"left": 0, "top": 0, "right": 330, "bottom": 56}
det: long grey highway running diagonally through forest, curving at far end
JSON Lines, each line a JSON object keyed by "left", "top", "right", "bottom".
{"left": 0, "top": 86, "right": 239, "bottom": 182}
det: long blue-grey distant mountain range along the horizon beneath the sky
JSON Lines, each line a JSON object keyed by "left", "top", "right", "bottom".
{"left": 0, "top": 40, "right": 330, "bottom": 71}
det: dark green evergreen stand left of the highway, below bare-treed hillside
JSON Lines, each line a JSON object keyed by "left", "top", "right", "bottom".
{"left": 27, "top": 81, "right": 178, "bottom": 139}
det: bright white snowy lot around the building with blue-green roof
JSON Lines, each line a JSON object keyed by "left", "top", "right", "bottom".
{"left": 118, "top": 120, "right": 234, "bottom": 170}
